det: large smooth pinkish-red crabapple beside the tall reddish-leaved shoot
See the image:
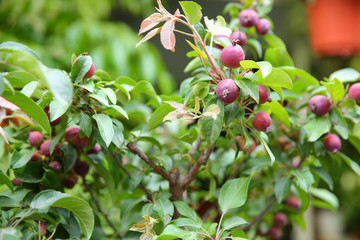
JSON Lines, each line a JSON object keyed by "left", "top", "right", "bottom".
{"left": 220, "top": 44, "right": 245, "bottom": 68}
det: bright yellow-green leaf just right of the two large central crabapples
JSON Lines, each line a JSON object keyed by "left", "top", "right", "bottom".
{"left": 255, "top": 68, "right": 293, "bottom": 88}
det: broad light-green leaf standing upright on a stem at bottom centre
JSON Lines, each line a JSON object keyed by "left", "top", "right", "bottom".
{"left": 219, "top": 176, "right": 251, "bottom": 213}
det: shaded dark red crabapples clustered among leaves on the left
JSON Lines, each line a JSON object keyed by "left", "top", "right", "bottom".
{"left": 12, "top": 53, "right": 101, "bottom": 188}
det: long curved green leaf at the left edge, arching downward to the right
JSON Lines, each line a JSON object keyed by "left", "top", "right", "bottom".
{"left": 2, "top": 90, "right": 51, "bottom": 134}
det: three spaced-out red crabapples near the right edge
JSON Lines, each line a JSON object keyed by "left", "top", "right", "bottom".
{"left": 309, "top": 83, "right": 360, "bottom": 153}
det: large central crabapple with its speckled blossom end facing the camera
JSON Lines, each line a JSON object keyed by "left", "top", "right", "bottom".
{"left": 216, "top": 79, "right": 240, "bottom": 103}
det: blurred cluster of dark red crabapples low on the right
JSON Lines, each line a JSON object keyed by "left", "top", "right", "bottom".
{"left": 257, "top": 196, "right": 301, "bottom": 240}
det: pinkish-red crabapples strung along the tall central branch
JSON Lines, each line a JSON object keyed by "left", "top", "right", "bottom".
{"left": 216, "top": 9, "right": 271, "bottom": 152}
